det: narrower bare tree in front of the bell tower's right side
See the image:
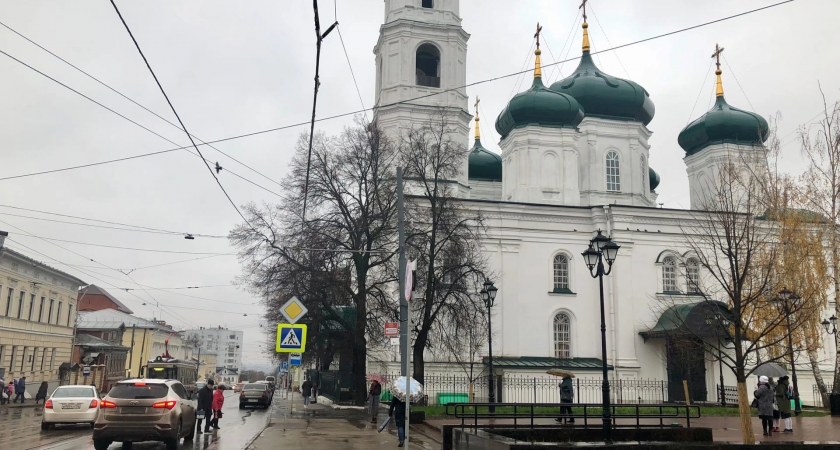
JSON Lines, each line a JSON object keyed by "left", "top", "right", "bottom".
{"left": 400, "top": 110, "right": 486, "bottom": 382}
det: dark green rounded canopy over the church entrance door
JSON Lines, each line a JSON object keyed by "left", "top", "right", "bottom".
{"left": 639, "top": 300, "right": 733, "bottom": 342}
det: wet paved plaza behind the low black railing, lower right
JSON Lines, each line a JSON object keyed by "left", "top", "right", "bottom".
{"left": 426, "top": 417, "right": 840, "bottom": 444}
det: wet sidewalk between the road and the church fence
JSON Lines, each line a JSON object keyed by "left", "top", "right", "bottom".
{"left": 247, "top": 394, "right": 440, "bottom": 450}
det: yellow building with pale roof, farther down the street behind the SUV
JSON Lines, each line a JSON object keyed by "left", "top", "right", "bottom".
{"left": 79, "top": 309, "right": 193, "bottom": 377}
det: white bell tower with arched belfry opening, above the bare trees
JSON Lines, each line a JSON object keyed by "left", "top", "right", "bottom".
{"left": 373, "top": 0, "right": 472, "bottom": 187}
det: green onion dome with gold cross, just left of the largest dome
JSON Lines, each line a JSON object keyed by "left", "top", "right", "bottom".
{"left": 496, "top": 49, "right": 583, "bottom": 138}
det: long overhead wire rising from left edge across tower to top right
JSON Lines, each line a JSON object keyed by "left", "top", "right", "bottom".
{"left": 0, "top": 0, "right": 795, "bottom": 181}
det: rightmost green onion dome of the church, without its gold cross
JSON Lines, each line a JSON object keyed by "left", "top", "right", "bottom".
{"left": 677, "top": 96, "right": 770, "bottom": 155}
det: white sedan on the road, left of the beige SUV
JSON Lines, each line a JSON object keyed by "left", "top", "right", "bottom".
{"left": 41, "top": 386, "right": 100, "bottom": 430}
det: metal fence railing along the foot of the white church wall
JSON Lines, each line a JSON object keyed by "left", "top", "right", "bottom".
{"left": 364, "top": 374, "right": 668, "bottom": 405}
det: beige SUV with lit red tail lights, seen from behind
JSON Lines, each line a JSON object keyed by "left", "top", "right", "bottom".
{"left": 93, "top": 379, "right": 196, "bottom": 450}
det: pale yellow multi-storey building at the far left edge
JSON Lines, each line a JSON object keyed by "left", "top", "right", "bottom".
{"left": 0, "top": 231, "right": 86, "bottom": 397}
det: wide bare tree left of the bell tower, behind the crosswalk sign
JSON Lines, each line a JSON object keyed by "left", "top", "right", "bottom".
{"left": 230, "top": 122, "right": 396, "bottom": 404}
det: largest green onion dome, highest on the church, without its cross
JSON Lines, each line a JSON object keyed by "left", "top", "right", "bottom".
{"left": 551, "top": 51, "right": 656, "bottom": 125}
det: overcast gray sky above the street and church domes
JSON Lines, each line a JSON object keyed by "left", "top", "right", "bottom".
{"left": 0, "top": 0, "right": 840, "bottom": 363}
